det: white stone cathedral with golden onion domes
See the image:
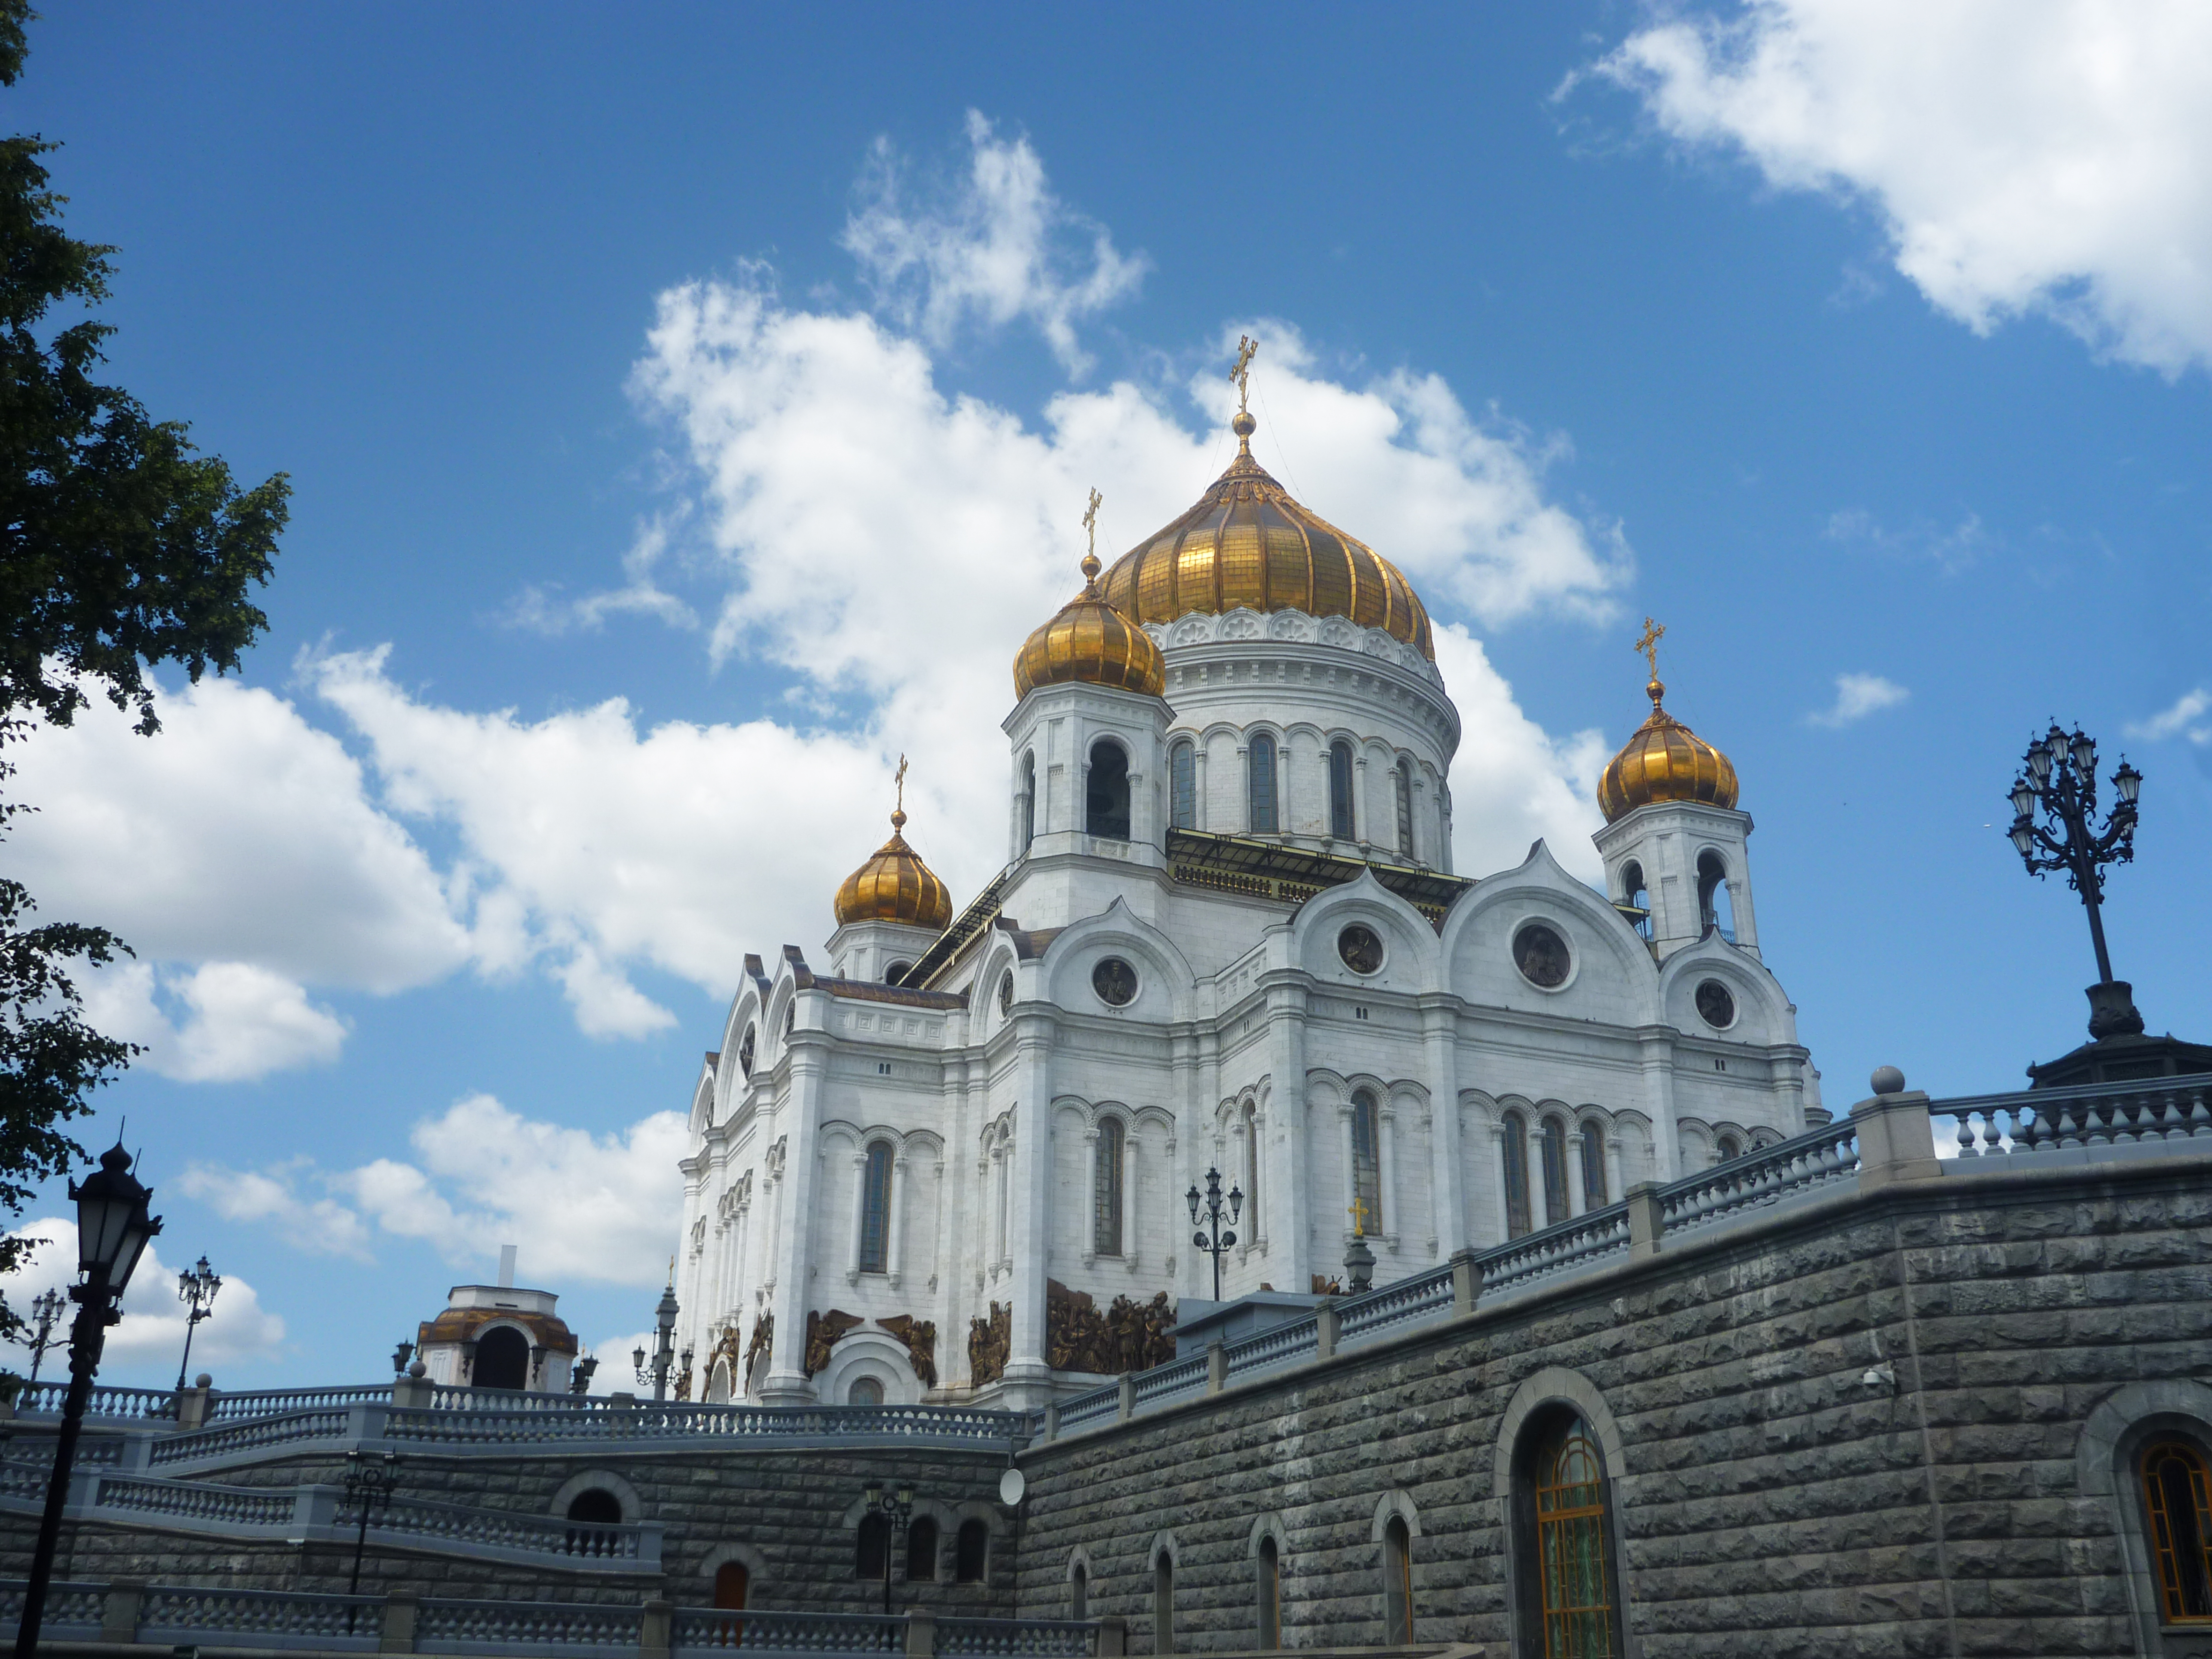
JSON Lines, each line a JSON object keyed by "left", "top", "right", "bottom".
{"left": 675, "top": 396, "right": 1827, "bottom": 1409}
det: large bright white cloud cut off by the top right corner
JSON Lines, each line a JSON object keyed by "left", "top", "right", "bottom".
{"left": 1597, "top": 0, "right": 2212, "bottom": 374}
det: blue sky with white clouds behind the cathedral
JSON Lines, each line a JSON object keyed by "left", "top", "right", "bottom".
{"left": 7, "top": 0, "right": 2212, "bottom": 1387}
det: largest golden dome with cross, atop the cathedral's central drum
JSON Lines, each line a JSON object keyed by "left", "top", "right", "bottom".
{"left": 1106, "top": 412, "right": 1436, "bottom": 661}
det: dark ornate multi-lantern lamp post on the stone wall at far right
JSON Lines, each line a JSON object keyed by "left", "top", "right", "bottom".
{"left": 2008, "top": 721, "right": 2144, "bottom": 1040}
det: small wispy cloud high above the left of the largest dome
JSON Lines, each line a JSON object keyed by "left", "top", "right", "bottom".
{"left": 845, "top": 111, "right": 1150, "bottom": 372}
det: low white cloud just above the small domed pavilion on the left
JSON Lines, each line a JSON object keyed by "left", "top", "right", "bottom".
{"left": 196, "top": 1095, "right": 684, "bottom": 1285}
